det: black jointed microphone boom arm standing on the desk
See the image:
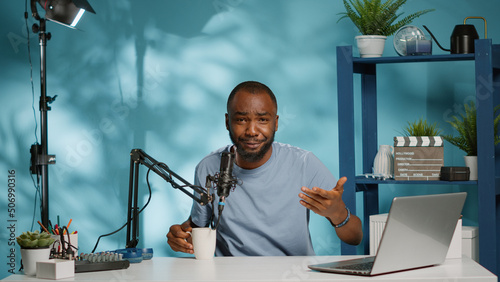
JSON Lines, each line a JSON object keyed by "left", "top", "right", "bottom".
{"left": 125, "top": 149, "right": 212, "bottom": 248}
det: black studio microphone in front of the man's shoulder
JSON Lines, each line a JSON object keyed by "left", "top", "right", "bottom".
{"left": 217, "top": 152, "right": 237, "bottom": 207}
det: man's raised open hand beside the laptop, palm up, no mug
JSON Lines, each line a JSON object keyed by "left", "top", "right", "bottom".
{"left": 299, "top": 177, "right": 347, "bottom": 224}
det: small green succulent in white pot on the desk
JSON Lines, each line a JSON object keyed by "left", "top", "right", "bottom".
{"left": 16, "top": 230, "right": 55, "bottom": 276}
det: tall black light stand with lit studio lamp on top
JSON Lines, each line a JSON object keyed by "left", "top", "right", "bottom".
{"left": 30, "top": 0, "right": 95, "bottom": 229}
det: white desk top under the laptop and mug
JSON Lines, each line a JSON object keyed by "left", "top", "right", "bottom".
{"left": 4, "top": 256, "right": 497, "bottom": 282}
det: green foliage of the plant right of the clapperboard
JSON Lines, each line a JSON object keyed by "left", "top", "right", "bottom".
{"left": 443, "top": 101, "right": 500, "bottom": 156}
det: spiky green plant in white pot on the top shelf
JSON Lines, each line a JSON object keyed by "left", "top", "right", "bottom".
{"left": 339, "top": 0, "right": 434, "bottom": 57}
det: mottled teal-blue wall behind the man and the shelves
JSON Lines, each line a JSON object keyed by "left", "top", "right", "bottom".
{"left": 0, "top": 0, "right": 500, "bottom": 278}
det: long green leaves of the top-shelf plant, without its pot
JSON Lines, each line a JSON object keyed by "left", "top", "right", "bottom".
{"left": 339, "top": 0, "right": 434, "bottom": 36}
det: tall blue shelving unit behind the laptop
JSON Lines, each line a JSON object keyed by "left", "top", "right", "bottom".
{"left": 337, "top": 39, "right": 500, "bottom": 274}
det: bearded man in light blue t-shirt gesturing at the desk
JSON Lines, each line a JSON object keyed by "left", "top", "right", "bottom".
{"left": 167, "top": 81, "right": 363, "bottom": 256}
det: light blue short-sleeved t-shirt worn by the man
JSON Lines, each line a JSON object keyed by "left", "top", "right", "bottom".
{"left": 191, "top": 142, "right": 336, "bottom": 256}
